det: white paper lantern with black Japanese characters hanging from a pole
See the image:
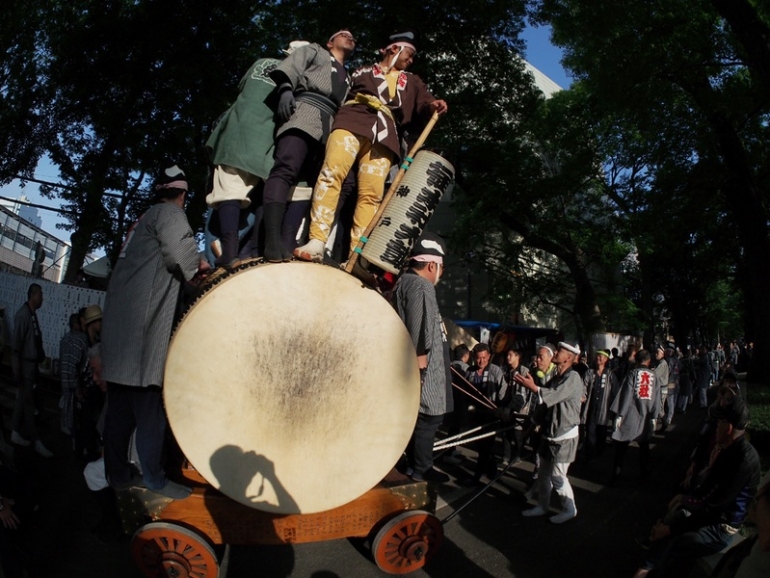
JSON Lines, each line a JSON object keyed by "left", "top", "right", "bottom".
{"left": 361, "top": 149, "right": 454, "bottom": 274}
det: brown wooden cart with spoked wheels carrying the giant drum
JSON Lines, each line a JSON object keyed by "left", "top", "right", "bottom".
{"left": 118, "top": 469, "right": 443, "bottom": 578}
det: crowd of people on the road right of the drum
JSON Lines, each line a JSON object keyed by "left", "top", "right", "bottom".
{"left": 416, "top": 342, "right": 770, "bottom": 578}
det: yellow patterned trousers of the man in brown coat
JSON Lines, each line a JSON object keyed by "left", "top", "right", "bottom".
{"left": 310, "top": 129, "right": 393, "bottom": 252}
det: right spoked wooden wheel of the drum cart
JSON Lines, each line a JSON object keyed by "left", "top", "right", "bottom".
{"left": 372, "top": 510, "right": 444, "bottom": 574}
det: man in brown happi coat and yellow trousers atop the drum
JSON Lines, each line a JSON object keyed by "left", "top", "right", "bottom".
{"left": 294, "top": 31, "right": 447, "bottom": 261}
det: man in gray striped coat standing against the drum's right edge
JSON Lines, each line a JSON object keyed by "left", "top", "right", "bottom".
{"left": 393, "top": 233, "right": 454, "bottom": 483}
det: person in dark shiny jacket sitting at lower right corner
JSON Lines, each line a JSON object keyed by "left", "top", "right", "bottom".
{"left": 634, "top": 397, "right": 759, "bottom": 578}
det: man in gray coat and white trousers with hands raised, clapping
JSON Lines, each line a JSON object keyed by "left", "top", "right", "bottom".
{"left": 514, "top": 341, "right": 583, "bottom": 524}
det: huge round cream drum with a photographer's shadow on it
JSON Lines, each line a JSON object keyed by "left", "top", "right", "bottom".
{"left": 164, "top": 262, "right": 420, "bottom": 514}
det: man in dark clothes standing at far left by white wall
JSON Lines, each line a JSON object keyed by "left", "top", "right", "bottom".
{"left": 11, "top": 283, "right": 53, "bottom": 458}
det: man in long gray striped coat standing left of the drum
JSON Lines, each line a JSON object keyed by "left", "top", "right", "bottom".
{"left": 101, "top": 166, "right": 209, "bottom": 499}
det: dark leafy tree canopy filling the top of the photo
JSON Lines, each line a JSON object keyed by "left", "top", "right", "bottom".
{"left": 0, "top": 0, "right": 770, "bottom": 382}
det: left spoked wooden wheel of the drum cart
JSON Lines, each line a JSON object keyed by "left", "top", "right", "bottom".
{"left": 131, "top": 522, "right": 219, "bottom": 578}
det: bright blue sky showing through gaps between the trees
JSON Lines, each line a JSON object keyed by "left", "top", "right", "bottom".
{"left": 0, "top": 26, "right": 572, "bottom": 241}
